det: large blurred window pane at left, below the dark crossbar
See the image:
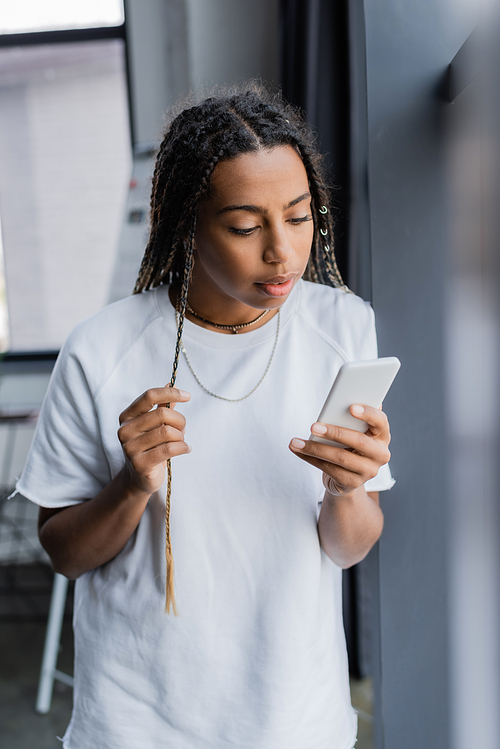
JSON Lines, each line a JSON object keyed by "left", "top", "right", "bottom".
{"left": 0, "top": 41, "right": 131, "bottom": 351}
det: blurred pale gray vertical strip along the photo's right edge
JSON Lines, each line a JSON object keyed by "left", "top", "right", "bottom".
{"left": 445, "top": 33, "right": 500, "bottom": 749}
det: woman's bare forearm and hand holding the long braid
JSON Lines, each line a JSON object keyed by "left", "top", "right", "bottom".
{"left": 38, "top": 386, "right": 191, "bottom": 580}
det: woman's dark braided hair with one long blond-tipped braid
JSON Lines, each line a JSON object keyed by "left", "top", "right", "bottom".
{"left": 134, "top": 81, "right": 347, "bottom": 614}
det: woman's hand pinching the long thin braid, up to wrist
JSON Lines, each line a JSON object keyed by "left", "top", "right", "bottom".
{"left": 118, "top": 385, "right": 191, "bottom": 494}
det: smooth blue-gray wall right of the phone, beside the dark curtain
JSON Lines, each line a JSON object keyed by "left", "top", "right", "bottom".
{"left": 365, "top": 0, "right": 493, "bottom": 749}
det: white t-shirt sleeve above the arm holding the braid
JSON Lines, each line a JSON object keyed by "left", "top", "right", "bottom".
{"left": 16, "top": 329, "right": 111, "bottom": 507}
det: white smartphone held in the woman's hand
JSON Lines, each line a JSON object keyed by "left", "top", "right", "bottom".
{"left": 309, "top": 356, "right": 401, "bottom": 447}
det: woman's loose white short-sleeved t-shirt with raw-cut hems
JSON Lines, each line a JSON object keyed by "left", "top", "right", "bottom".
{"left": 17, "top": 281, "right": 393, "bottom": 749}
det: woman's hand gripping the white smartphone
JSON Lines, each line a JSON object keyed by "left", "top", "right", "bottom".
{"left": 289, "top": 404, "right": 391, "bottom": 495}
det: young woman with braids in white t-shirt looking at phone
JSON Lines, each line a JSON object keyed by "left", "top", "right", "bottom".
{"left": 18, "top": 86, "right": 392, "bottom": 749}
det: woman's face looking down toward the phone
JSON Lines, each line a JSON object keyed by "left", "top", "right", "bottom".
{"left": 189, "top": 146, "right": 314, "bottom": 323}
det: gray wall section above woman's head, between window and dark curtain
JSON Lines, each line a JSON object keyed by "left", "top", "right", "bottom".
{"left": 125, "top": 0, "right": 279, "bottom": 144}
